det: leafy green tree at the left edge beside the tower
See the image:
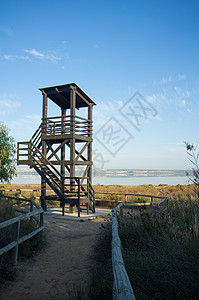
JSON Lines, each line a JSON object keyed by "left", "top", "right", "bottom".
{"left": 0, "top": 122, "right": 16, "bottom": 183}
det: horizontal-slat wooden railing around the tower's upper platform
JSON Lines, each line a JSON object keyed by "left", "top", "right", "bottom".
{"left": 42, "top": 115, "right": 92, "bottom": 136}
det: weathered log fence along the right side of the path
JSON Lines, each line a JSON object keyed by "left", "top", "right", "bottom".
{"left": 112, "top": 194, "right": 168, "bottom": 300}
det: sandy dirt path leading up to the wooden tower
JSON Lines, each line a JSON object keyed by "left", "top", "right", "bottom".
{"left": 0, "top": 216, "right": 104, "bottom": 300}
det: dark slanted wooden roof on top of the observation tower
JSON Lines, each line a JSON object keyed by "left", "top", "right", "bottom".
{"left": 39, "top": 83, "right": 96, "bottom": 109}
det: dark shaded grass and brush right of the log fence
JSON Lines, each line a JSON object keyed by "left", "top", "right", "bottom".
{"left": 120, "top": 197, "right": 199, "bottom": 300}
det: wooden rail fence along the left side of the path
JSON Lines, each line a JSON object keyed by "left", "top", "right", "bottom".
{"left": 0, "top": 195, "right": 44, "bottom": 265}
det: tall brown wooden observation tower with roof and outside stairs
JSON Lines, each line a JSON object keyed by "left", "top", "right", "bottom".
{"left": 17, "top": 83, "right": 95, "bottom": 216}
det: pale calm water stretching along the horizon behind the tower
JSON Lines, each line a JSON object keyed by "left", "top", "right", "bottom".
{"left": 11, "top": 176, "right": 191, "bottom": 185}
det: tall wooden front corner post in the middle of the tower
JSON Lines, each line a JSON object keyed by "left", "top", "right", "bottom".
{"left": 69, "top": 90, "right": 76, "bottom": 213}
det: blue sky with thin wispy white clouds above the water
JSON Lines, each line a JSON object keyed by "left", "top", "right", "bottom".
{"left": 0, "top": 0, "right": 199, "bottom": 169}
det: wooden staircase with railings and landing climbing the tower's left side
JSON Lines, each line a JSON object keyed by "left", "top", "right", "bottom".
{"left": 17, "top": 124, "right": 95, "bottom": 216}
